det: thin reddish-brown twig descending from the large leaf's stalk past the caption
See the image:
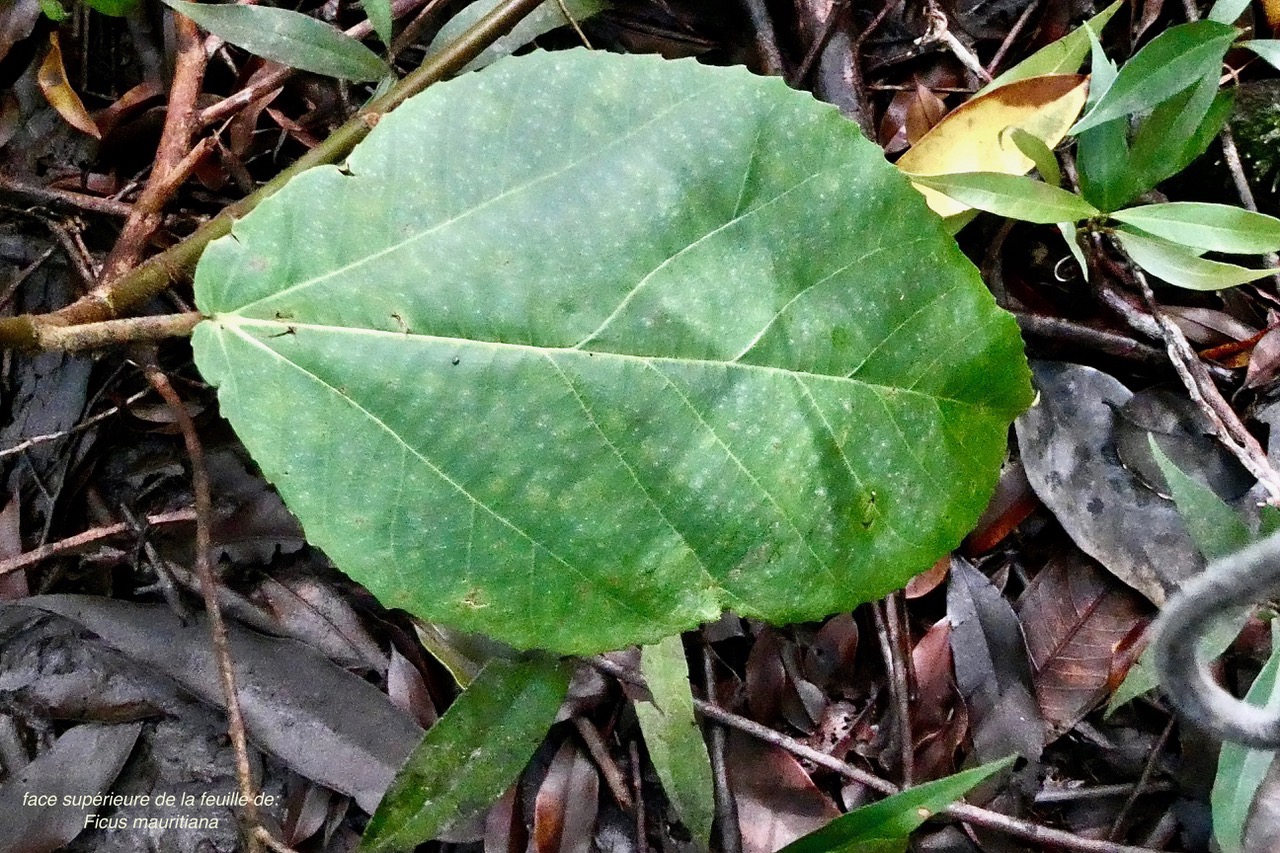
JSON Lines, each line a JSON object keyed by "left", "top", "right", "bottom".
{"left": 143, "top": 361, "right": 262, "bottom": 853}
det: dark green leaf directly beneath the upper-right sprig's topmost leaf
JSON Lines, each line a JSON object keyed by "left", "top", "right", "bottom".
{"left": 1124, "top": 69, "right": 1233, "bottom": 202}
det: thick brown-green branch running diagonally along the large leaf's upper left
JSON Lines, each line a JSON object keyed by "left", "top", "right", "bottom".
{"left": 0, "top": 0, "right": 552, "bottom": 350}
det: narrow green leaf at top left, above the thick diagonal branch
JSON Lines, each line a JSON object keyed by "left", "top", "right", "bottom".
{"left": 164, "top": 0, "right": 392, "bottom": 81}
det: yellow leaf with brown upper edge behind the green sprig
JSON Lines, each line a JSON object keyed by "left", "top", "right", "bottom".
{"left": 897, "top": 74, "right": 1089, "bottom": 216}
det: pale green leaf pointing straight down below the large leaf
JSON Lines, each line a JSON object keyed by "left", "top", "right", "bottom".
{"left": 636, "top": 634, "right": 716, "bottom": 849}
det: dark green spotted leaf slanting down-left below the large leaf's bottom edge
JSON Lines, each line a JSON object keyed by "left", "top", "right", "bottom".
{"left": 360, "top": 657, "right": 573, "bottom": 853}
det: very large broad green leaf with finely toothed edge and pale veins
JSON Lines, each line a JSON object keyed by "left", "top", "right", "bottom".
{"left": 195, "top": 50, "right": 1030, "bottom": 653}
